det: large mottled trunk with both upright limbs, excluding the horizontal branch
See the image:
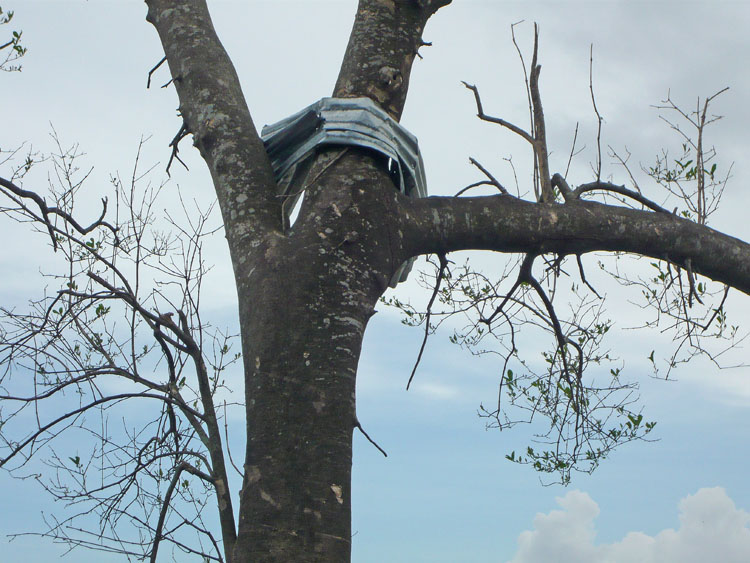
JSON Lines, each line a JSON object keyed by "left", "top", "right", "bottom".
{"left": 147, "top": 0, "right": 450, "bottom": 562}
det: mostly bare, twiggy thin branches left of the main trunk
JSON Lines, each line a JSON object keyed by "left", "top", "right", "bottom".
{"left": 0, "top": 136, "right": 239, "bottom": 561}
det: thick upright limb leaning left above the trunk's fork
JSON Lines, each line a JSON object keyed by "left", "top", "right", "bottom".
{"left": 146, "top": 0, "right": 282, "bottom": 240}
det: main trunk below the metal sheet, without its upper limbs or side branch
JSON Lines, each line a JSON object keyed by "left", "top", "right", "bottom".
{"left": 233, "top": 149, "right": 412, "bottom": 562}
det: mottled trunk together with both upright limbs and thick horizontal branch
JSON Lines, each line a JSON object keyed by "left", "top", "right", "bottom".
{"left": 146, "top": 0, "right": 750, "bottom": 563}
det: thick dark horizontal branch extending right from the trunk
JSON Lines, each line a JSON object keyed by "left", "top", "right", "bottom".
{"left": 402, "top": 195, "right": 750, "bottom": 294}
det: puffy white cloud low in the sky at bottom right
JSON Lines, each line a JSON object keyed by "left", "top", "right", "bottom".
{"left": 511, "top": 487, "right": 750, "bottom": 563}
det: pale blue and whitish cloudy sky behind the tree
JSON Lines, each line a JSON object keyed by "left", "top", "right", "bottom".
{"left": 0, "top": 0, "right": 750, "bottom": 563}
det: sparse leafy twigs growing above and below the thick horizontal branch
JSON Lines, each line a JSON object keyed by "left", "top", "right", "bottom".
{"left": 384, "top": 24, "right": 745, "bottom": 484}
